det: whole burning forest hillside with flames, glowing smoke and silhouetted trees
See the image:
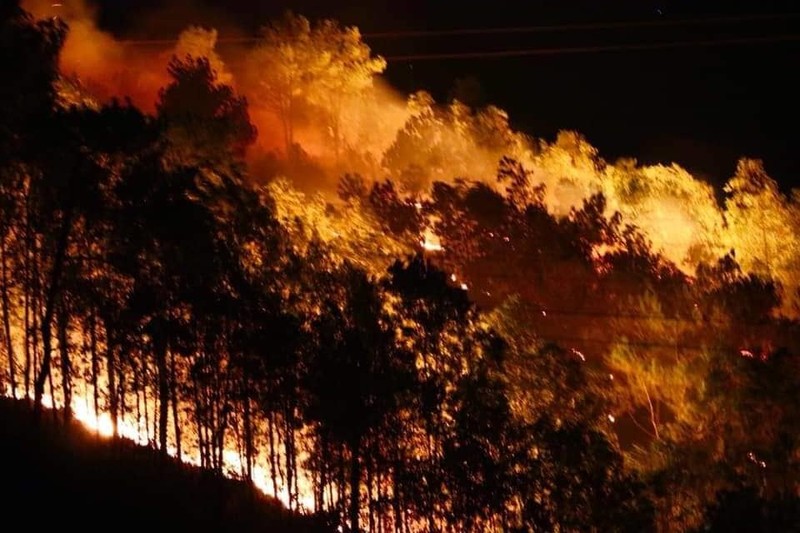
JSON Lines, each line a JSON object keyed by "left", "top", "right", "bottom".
{"left": 0, "top": 1, "right": 800, "bottom": 533}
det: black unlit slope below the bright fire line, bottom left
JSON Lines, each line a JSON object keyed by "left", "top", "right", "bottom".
{"left": 0, "top": 399, "right": 329, "bottom": 532}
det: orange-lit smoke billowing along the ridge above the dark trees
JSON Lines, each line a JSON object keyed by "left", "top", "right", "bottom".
{"left": 23, "top": 0, "right": 796, "bottom": 296}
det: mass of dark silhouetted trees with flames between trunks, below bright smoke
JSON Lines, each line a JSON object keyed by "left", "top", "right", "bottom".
{"left": 0, "top": 3, "right": 800, "bottom": 532}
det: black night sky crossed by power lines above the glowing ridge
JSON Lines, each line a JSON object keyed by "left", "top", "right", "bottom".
{"left": 90, "top": 0, "right": 800, "bottom": 188}
